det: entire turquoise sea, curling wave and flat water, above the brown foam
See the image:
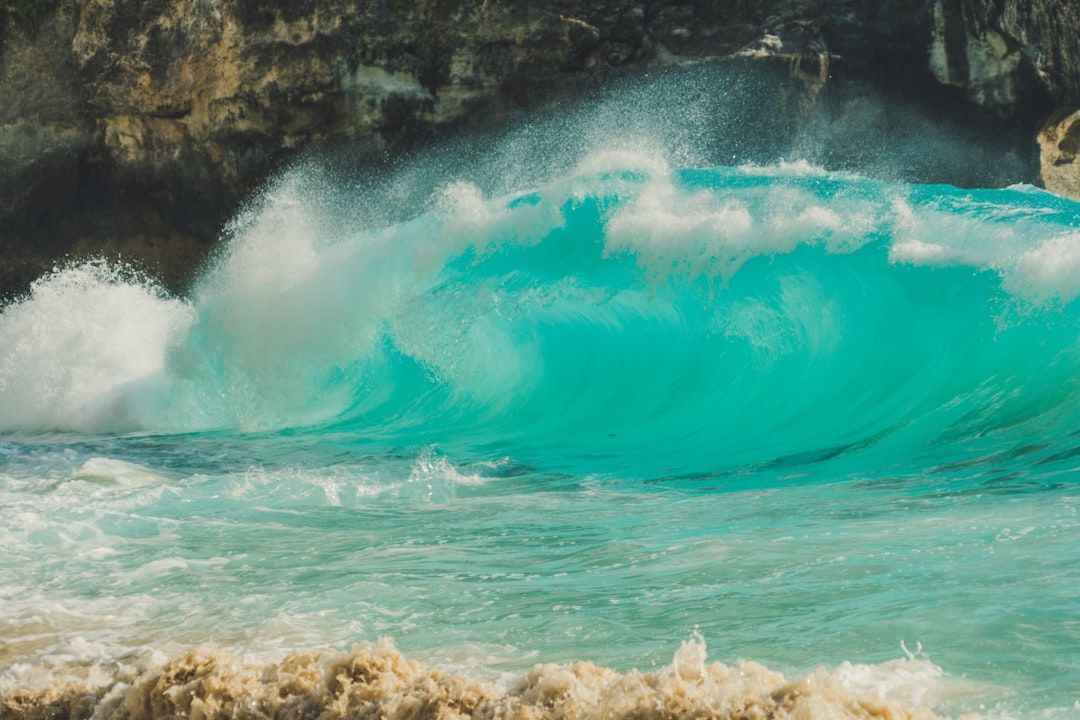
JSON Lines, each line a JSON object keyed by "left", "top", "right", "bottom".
{"left": 0, "top": 150, "right": 1080, "bottom": 719}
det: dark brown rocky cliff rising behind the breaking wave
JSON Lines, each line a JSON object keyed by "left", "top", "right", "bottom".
{"left": 0, "top": 0, "right": 1080, "bottom": 294}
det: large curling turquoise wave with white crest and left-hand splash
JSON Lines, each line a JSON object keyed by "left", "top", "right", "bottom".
{"left": 0, "top": 153, "right": 1080, "bottom": 475}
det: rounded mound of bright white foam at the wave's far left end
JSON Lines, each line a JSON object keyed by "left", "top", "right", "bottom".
{"left": 0, "top": 261, "right": 193, "bottom": 431}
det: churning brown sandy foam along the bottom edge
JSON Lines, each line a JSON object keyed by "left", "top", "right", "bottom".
{"left": 0, "top": 639, "right": 936, "bottom": 720}
